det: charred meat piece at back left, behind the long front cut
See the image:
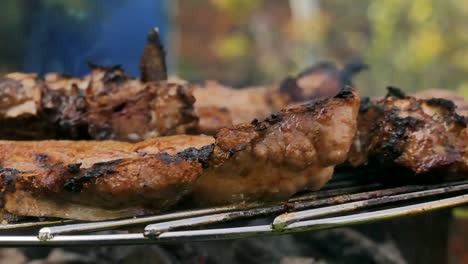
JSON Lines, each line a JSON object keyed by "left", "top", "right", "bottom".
{"left": 0, "top": 66, "right": 198, "bottom": 141}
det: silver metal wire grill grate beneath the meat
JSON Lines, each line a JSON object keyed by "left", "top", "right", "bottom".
{"left": 0, "top": 168, "right": 468, "bottom": 246}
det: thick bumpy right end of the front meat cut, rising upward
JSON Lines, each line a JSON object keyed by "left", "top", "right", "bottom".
{"left": 193, "top": 86, "right": 359, "bottom": 204}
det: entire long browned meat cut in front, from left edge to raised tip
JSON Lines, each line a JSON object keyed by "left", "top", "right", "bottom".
{"left": 0, "top": 87, "right": 359, "bottom": 220}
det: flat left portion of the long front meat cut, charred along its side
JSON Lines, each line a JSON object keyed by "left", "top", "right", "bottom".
{"left": 0, "top": 136, "right": 212, "bottom": 220}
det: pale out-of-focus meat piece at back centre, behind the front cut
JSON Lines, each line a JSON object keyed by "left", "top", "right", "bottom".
{"left": 194, "top": 62, "right": 367, "bottom": 134}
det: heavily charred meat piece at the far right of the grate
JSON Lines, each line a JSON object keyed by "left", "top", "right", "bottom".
{"left": 349, "top": 87, "right": 468, "bottom": 175}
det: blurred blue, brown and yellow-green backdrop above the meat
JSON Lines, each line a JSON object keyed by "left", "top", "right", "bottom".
{"left": 0, "top": 0, "right": 468, "bottom": 95}
